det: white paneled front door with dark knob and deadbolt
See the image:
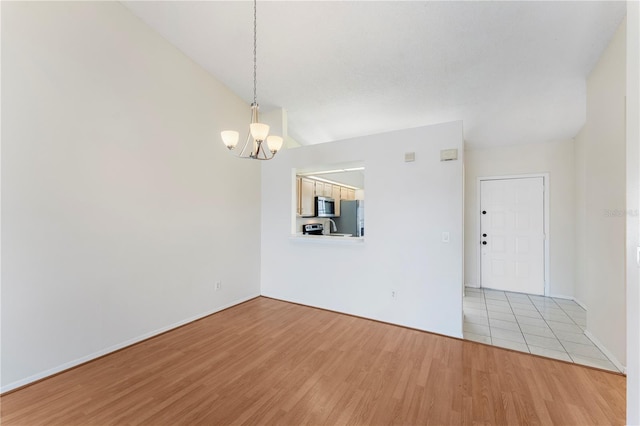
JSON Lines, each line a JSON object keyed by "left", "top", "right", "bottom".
{"left": 480, "top": 177, "right": 545, "bottom": 294}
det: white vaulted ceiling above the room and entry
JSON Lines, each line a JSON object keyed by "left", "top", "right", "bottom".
{"left": 123, "top": 1, "right": 626, "bottom": 147}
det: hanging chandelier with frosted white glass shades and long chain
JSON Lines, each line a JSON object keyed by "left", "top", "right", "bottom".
{"left": 220, "top": 0, "right": 283, "bottom": 160}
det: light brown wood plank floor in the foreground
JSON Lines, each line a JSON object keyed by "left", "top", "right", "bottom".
{"left": 0, "top": 297, "right": 626, "bottom": 425}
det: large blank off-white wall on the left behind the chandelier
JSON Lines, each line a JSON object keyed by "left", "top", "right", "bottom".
{"left": 1, "top": 2, "right": 260, "bottom": 391}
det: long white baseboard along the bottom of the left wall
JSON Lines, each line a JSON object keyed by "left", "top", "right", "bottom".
{"left": 0, "top": 293, "right": 260, "bottom": 394}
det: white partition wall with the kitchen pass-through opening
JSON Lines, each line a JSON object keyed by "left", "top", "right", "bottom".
{"left": 261, "top": 122, "right": 463, "bottom": 337}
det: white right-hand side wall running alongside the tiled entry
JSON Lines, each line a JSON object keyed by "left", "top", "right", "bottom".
{"left": 575, "top": 21, "right": 626, "bottom": 365}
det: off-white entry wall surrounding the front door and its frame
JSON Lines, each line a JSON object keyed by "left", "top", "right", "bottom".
{"left": 464, "top": 140, "right": 575, "bottom": 297}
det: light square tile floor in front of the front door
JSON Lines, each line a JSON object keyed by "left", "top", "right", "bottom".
{"left": 463, "top": 287, "right": 619, "bottom": 372}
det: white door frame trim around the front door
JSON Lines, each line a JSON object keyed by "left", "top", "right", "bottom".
{"left": 473, "top": 173, "right": 549, "bottom": 296}
